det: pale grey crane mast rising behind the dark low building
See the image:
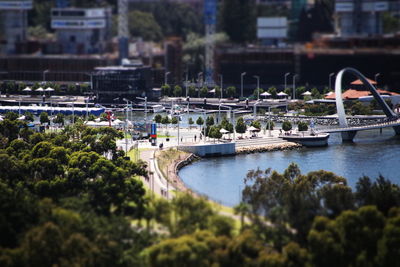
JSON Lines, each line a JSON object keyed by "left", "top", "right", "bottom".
{"left": 118, "top": 0, "right": 129, "bottom": 63}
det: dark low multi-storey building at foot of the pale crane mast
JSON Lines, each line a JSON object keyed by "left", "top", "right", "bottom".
{"left": 92, "top": 65, "right": 153, "bottom": 104}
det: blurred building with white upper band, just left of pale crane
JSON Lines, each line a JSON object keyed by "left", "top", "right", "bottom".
{"left": 51, "top": 8, "right": 112, "bottom": 54}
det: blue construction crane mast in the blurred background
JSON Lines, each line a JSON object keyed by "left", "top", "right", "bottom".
{"left": 204, "top": 0, "right": 217, "bottom": 86}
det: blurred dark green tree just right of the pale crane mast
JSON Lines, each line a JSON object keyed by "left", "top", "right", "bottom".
{"left": 128, "top": 10, "right": 163, "bottom": 42}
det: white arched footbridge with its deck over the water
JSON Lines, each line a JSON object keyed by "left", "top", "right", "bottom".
{"left": 316, "top": 68, "right": 400, "bottom": 141}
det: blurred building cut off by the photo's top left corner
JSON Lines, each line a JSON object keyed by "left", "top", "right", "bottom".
{"left": 0, "top": 0, "right": 32, "bottom": 54}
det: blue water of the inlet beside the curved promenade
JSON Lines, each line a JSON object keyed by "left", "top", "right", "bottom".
{"left": 179, "top": 128, "right": 400, "bottom": 206}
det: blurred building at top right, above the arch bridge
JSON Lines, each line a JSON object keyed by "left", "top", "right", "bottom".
{"left": 335, "top": 0, "right": 389, "bottom": 37}
